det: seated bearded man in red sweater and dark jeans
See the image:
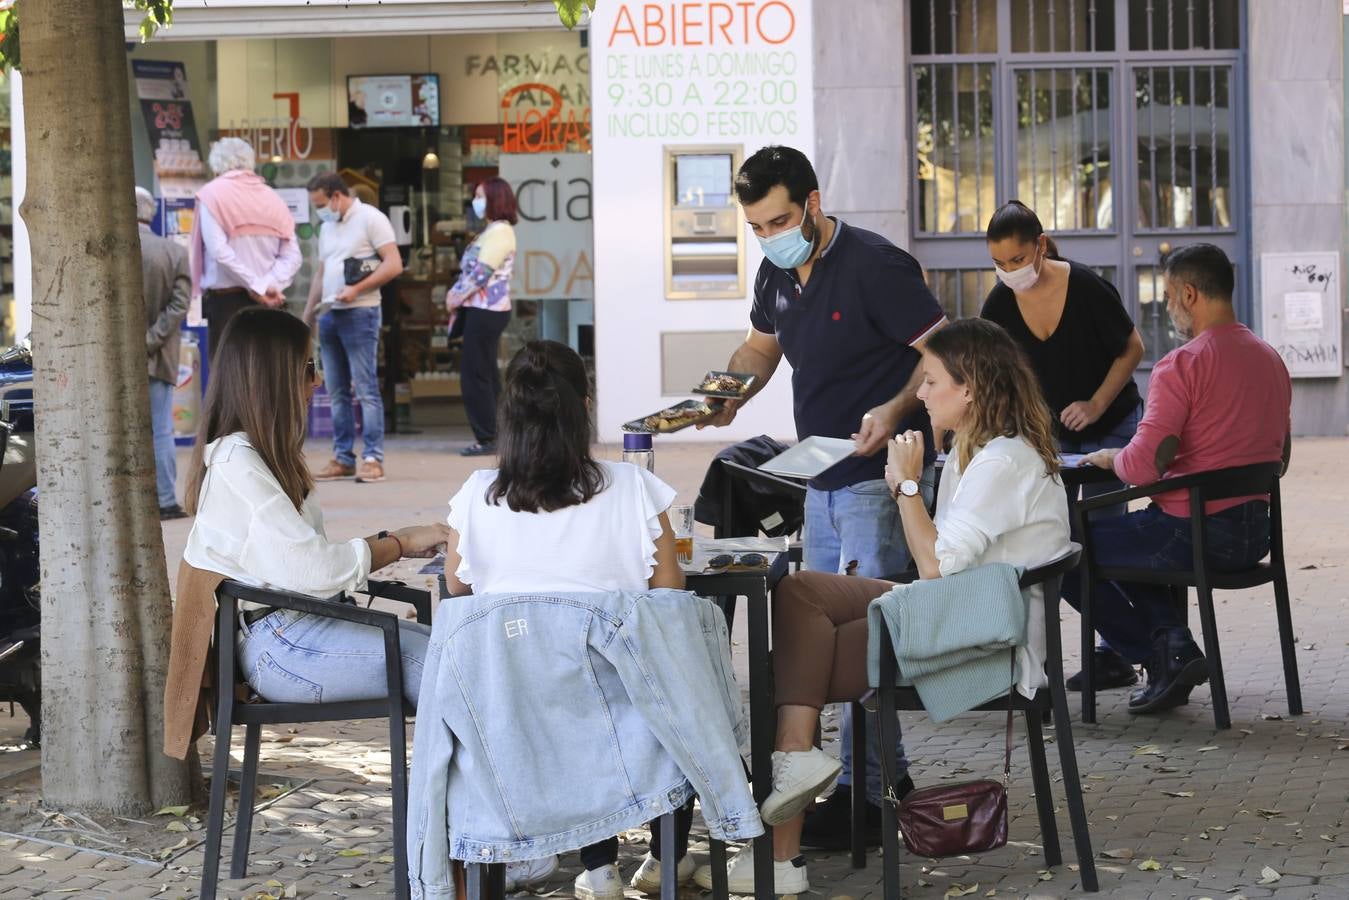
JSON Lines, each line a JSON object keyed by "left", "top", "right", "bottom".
{"left": 1063, "top": 244, "right": 1292, "bottom": 712}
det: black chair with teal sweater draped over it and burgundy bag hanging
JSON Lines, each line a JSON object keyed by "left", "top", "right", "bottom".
{"left": 874, "top": 544, "right": 1099, "bottom": 900}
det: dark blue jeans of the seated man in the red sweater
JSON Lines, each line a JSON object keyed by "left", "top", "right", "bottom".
{"left": 1063, "top": 501, "right": 1269, "bottom": 664}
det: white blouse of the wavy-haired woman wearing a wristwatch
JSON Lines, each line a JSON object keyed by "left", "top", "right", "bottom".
{"left": 935, "top": 437, "right": 1070, "bottom": 698}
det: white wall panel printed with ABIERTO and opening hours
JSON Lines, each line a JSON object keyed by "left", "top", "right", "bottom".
{"left": 590, "top": 0, "right": 815, "bottom": 443}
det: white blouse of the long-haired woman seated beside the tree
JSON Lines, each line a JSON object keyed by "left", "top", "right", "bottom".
{"left": 182, "top": 432, "right": 370, "bottom": 598}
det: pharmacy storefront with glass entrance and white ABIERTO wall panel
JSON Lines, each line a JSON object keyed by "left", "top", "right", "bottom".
{"left": 7, "top": 0, "right": 815, "bottom": 441}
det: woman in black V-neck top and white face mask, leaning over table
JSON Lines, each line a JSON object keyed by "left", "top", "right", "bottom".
{"left": 981, "top": 200, "right": 1143, "bottom": 691}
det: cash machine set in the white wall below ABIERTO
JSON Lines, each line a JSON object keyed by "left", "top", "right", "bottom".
{"left": 664, "top": 144, "right": 745, "bottom": 300}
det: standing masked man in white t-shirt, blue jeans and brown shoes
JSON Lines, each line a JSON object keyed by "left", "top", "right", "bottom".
{"left": 305, "top": 173, "right": 403, "bottom": 482}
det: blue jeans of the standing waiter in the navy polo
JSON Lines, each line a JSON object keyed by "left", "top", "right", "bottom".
{"left": 801, "top": 466, "right": 935, "bottom": 804}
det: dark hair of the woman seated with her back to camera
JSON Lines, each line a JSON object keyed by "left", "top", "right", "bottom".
{"left": 487, "top": 340, "right": 607, "bottom": 513}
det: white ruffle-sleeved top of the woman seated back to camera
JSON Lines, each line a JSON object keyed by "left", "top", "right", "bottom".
{"left": 449, "top": 460, "right": 675, "bottom": 594}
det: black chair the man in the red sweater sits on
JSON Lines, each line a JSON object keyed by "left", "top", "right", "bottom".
{"left": 1072, "top": 461, "right": 1302, "bottom": 729}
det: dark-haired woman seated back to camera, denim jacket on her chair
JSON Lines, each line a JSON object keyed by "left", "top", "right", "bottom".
{"left": 445, "top": 340, "right": 693, "bottom": 900}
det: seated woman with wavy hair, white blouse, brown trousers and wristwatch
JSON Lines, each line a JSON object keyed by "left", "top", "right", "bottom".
{"left": 700, "top": 318, "right": 1070, "bottom": 893}
